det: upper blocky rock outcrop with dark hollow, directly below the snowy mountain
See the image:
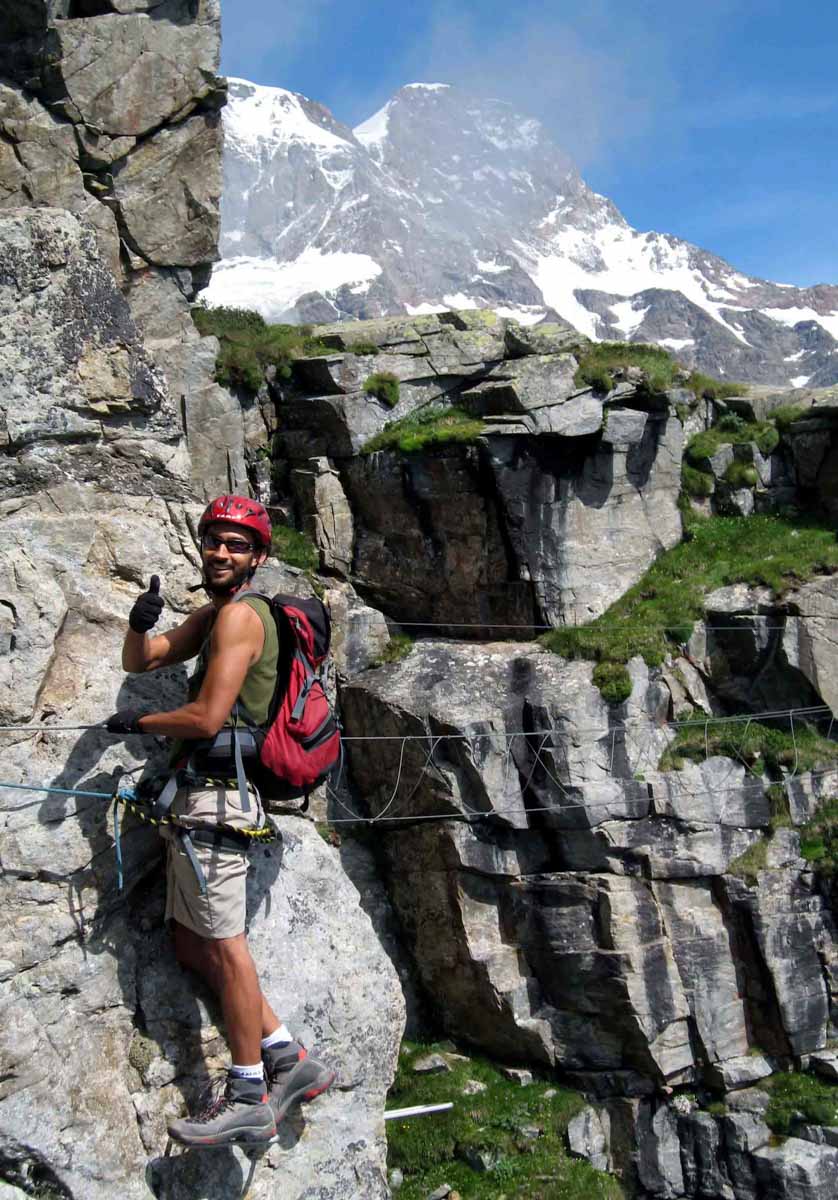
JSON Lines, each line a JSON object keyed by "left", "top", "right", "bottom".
{"left": 277, "top": 312, "right": 683, "bottom": 637}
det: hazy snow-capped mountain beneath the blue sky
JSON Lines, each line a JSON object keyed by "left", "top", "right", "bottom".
{"left": 206, "top": 79, "right": 838, "bottom": 386}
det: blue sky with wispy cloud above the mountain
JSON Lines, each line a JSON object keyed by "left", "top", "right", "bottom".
{"left": 222, "top": 0, "right": 838, "bottom": 286}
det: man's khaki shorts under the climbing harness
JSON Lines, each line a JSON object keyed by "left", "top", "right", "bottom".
{"left": 161, "top": 787, "right": 263, "bottom": 940}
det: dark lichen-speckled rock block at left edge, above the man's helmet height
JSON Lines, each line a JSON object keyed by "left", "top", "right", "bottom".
{"left": 0, "top": 209, "right": 188, "bottom": 496}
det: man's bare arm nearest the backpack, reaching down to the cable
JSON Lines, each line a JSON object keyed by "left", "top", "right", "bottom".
{"left": 139, "top": 604, "right": 264, "bottom": 738}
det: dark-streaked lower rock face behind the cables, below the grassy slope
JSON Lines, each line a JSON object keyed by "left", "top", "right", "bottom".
{"left": 342, "top": 641, "right": 838, "bottom": 1198}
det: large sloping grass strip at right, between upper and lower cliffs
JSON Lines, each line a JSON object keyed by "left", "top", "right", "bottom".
{"left": 540, "top": 516, "right": 838, "bottom": 666}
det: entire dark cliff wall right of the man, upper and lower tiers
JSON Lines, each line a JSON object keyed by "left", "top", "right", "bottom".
{"left": 271, "top": 313, "right": 838, "bottom": 1200}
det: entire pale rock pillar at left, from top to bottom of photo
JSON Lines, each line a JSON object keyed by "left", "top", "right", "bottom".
{"left": 0, "top": 0, "right": 405, "bottom": 1200}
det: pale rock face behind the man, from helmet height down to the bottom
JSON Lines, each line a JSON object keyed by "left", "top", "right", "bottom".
{"left": 0, "top": 482, "right": 405, "bottom": 1200}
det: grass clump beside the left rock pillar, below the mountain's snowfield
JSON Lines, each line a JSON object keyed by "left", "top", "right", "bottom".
{"left": 192, "top": 305, "right": 334, "bottom": 392}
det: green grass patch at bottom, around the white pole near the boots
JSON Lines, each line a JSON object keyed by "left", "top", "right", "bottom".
{"left": 387, "top": 1043, "right": 622, "bottom": 1200}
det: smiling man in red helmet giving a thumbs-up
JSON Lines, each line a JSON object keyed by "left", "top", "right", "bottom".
{"left": 107, "top": 496, "right": 334, "bottom": 1145}
